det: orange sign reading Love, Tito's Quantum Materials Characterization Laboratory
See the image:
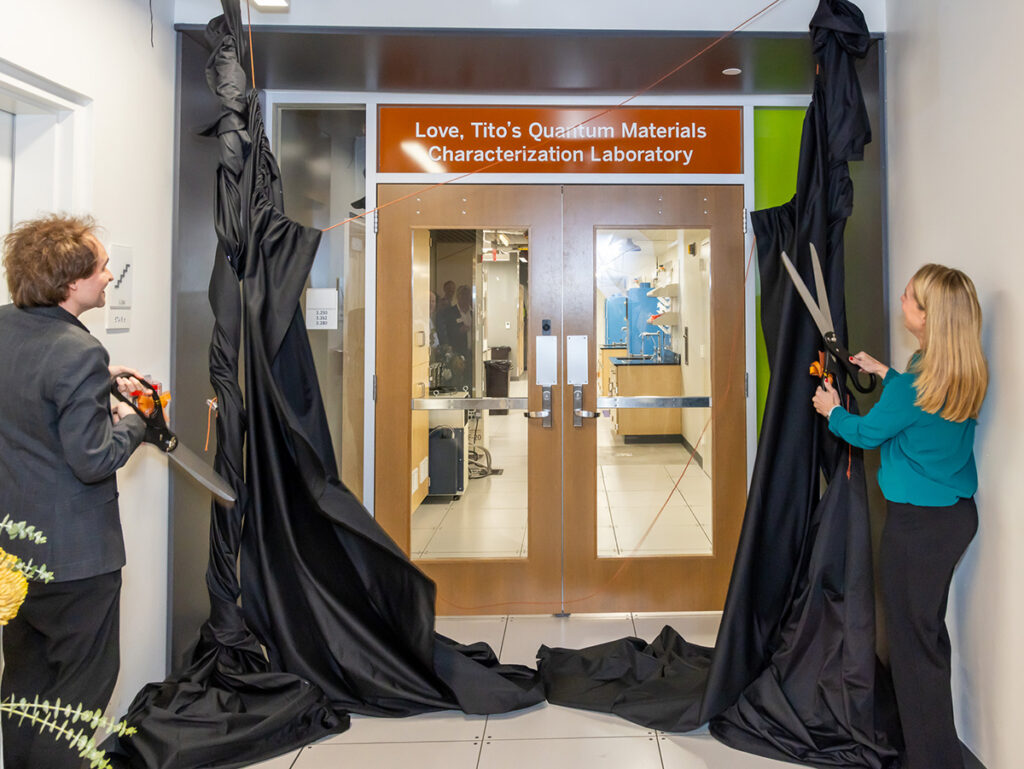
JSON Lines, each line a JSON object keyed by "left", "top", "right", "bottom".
{"left": 378, "top": 105, "right": 743, "bottom": 174}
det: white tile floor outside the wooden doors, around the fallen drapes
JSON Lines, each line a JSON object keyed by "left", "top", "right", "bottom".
{"left": 250, "top": 613, "right": 795, "bottom": 769}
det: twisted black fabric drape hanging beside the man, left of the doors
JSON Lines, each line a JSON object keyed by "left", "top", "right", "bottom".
{"left": 106, "top": 0, "right": 543, "bottom": 769}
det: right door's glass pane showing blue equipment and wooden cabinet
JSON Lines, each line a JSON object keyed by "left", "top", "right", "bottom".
{"left": 595, "top": 229, "right": 713, "bottom": 558}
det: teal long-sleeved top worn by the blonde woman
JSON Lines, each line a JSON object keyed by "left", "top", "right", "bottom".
{"left": 828, "top": 369, "right": 978, "bottom": 507}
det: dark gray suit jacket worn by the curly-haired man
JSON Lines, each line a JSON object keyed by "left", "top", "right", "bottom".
{"left": 0, "top": 304, "right": 145, "bottom": 582}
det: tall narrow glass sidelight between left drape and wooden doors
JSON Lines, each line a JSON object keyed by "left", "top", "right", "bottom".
{"left": 278, "top": 106, "right": 367, "bottom": 500}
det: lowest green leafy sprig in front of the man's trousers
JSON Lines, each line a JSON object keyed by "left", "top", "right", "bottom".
{"left": 0, "top": 695, "right": 136, "bottom": 769}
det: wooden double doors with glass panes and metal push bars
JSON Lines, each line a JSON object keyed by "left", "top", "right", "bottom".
{"left": 375, "top": 184, "right": 746, "bottom": 614}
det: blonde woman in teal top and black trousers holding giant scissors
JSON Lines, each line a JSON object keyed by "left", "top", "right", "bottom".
{"left": 813, "top": 264, "right": 988, "bottom": 769}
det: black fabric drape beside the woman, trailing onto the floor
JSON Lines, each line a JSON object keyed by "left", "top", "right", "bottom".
{"left": 539, "top": 0, "right": 896, "bottom": 769}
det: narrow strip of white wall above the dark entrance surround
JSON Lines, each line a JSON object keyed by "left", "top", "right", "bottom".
{"left": 174, "top": 0, "right": 886, "bottom": 32}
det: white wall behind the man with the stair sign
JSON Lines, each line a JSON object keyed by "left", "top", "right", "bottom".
{"left": 0, "top": 0, "right": 176, "bottom": 714}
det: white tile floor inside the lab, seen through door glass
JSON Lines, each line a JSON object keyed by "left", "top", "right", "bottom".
{"left": 412, "top": 381, "right": 712, "bottom": 558}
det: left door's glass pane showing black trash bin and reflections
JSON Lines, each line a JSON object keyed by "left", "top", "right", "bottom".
{"left": 411, "top": 227, "right": 529, "bottom": 559}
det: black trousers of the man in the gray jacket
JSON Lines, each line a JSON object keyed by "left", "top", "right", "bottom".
{"left": 2, "top": 570, "right": 121, "bottom": 769}
